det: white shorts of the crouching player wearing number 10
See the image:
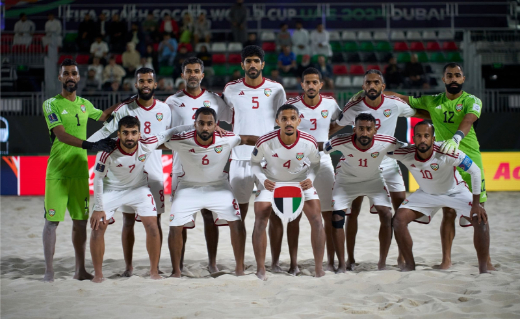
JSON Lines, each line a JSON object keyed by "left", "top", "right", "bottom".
{"left": 399, "top": 184, "right": 473, "bottom": 227}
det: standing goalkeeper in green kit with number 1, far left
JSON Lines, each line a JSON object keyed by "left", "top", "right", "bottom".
{"left": 42, "top": 59, "right": 115, "bottom": 282}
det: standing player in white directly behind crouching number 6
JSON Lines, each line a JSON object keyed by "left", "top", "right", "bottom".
{"left": 165, "top": 57, "right": 231, "bottom": 273}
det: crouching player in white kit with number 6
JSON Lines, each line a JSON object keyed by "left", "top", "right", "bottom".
{"left": 160, "top": 107, "right": 258, "bottom": 277}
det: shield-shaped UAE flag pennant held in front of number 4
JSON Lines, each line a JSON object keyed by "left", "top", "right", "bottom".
{"left": 272, "top": 182, "right": 305, "bottom": 222}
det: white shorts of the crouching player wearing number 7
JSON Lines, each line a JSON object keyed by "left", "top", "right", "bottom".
{"left": 103, "top": 186, "right": 157, "bottom": 220}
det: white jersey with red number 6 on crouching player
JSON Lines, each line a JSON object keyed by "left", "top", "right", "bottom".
{"left": 164, "top": 130, "right": 241, "bottom": 186}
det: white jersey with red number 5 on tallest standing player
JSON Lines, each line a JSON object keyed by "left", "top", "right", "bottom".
{"left": 222, "top": 78, "right": 287, "bottom": 160}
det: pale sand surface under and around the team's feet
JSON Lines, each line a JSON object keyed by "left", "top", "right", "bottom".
{"left": 0, "top": 192, "right": 520, "bottom": 319}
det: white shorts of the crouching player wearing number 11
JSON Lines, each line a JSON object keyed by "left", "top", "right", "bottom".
{"left": 332, "top": 177, "right": 392, "bottom": 215}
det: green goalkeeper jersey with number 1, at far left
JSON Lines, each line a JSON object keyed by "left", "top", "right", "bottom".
{"left": 43, "top": 94, "right": 103, "bottom": 179}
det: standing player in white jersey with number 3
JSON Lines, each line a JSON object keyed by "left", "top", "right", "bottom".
{"left": 269, "top": 68, "right": 341, "bottom": 275}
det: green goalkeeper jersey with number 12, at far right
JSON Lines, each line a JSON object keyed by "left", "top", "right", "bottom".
{"left": 409, "top": 91, "right": 482, "bottom": 155}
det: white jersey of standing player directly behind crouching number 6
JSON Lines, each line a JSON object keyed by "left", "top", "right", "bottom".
{"left": 165, "top": 89, "right": 232, "bottom": 174}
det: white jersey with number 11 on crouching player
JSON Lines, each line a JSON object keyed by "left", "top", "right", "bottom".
{"left": 323, "top": 133, "right": 406, "bottom": 183}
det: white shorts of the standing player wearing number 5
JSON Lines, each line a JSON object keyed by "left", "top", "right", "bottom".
{"left": 229, "top": 160, "right": 255, "bottom": 204}
